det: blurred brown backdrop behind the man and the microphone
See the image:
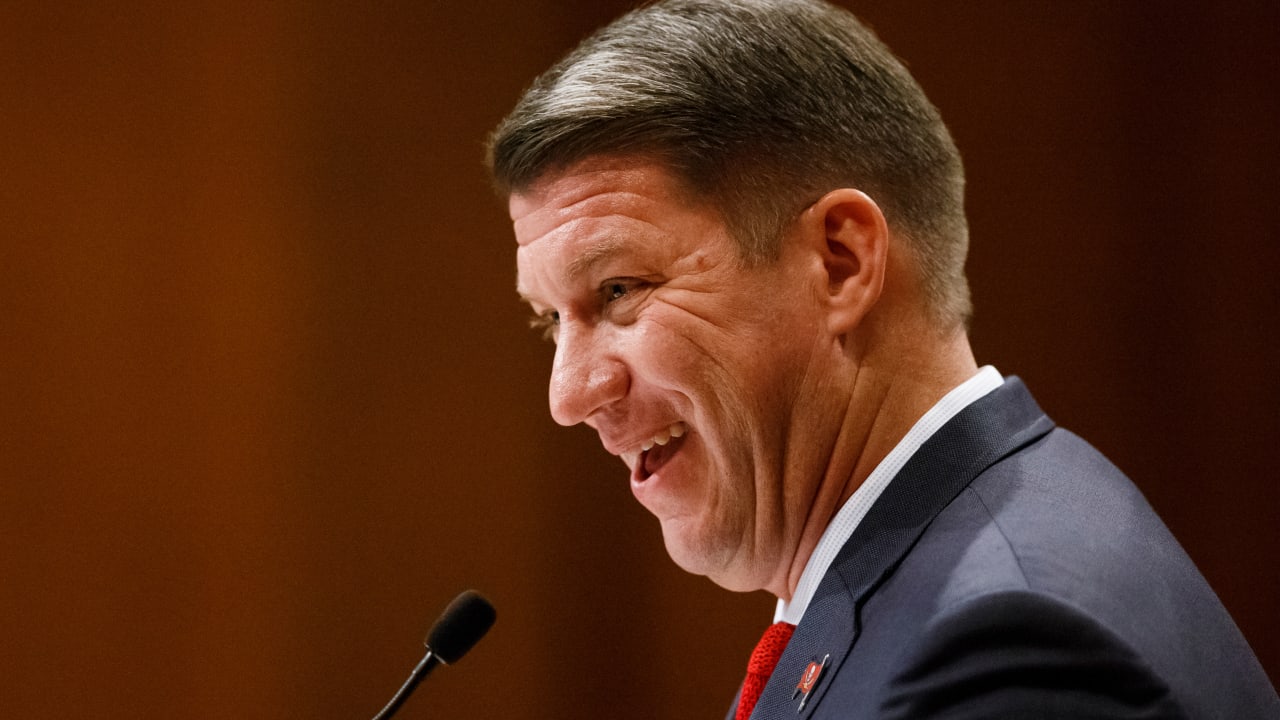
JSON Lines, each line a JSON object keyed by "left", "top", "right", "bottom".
{"left": 0, "top": 0, "right": 1280, "bottom": 719}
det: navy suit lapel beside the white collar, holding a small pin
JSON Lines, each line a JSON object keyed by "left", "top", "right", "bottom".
{"left": 751, "top": 377, "right": 1053, "bottom": 720}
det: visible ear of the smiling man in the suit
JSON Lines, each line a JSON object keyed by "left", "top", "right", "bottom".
{"left": 803, "top": 188, "right": 888, "bottom": 336}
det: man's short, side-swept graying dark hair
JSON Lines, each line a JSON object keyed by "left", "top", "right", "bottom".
{"left": 489, "top": 0, "right": 970, "bottom": 327}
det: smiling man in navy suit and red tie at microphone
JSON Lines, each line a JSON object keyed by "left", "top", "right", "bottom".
{"left": 490, "top": 0, "right": 1280, "bottom": 719}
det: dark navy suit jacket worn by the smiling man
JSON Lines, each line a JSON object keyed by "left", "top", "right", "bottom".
{"left": 730, "top": 378, "right": 1280, "bottom": 720}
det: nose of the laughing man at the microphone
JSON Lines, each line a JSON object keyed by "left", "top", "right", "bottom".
{"left": 548, "top": 323, "right": 630, "bottom": 425}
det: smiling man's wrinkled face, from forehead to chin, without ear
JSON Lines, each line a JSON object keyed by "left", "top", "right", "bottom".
{"left": 511, "top": 159, "right": 822, "bottom": 589}
